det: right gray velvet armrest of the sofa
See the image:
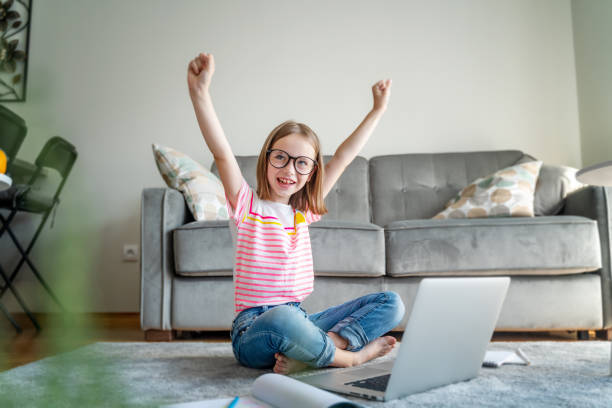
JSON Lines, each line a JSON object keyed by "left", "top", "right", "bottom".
{"left": 562, "top": 186, "right": 612, "bottom": 328}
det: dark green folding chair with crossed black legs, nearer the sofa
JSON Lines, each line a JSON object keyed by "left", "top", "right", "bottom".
{"left": 0, "top": 136, "right": 77, "bottom": 328}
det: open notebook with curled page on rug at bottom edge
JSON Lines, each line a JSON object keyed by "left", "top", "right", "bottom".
{"left": 164, "top": 373, "right": 363, "bottom": 408}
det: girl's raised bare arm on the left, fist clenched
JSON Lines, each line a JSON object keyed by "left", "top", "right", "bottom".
{"left": 187, "top": 53, "right": 242, "bottom": 208}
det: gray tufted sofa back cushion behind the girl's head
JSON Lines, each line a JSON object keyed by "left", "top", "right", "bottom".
{"left": 211, "top": 156, "right": 370, "bottom": 223}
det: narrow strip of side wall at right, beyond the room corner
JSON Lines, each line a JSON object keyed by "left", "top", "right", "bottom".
{"left": 572, "top": 0, "right": 612, "bottom": 166}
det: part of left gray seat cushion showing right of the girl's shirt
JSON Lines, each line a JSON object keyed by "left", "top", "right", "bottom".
{"left": 308, "top": 220, "right": 385, "bottom": 277}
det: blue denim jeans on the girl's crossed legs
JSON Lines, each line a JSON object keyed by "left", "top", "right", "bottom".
{"left": 230, "top": 292, "right": 405, "bottom": 368}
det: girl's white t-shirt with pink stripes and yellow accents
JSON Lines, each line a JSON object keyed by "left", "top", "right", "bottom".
{"left": 226, "top": 180, "right": 321, "bottom": 314}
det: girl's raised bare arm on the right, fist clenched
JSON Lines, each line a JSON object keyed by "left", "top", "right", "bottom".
{"left": 323, "top": 79, "right": 391, "bottom": 198}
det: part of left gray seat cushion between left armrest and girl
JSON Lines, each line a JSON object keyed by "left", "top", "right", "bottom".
{"left": 173, "top": 220, "right": 234, "bottom": 276}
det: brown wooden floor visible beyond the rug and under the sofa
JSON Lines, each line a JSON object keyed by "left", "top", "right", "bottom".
{"left": 0, "top": 313, "right": 597, "bottom": 371}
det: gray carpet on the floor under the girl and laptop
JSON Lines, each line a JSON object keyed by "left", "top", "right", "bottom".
{"left": 0, "top": 342, "right": 612, "bottom": 408}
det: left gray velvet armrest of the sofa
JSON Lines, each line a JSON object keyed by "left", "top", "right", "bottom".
{"left": 140, "top": 188, "right": 191, "bottom": 330}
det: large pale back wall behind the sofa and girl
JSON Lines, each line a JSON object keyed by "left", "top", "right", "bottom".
{"left": 2, "top": 0, "right": 581, "bottom": 312}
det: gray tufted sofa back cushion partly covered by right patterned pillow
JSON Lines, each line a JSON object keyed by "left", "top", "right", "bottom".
{"left": 369, "top": 150, "right": 533, "bottom": 226}
